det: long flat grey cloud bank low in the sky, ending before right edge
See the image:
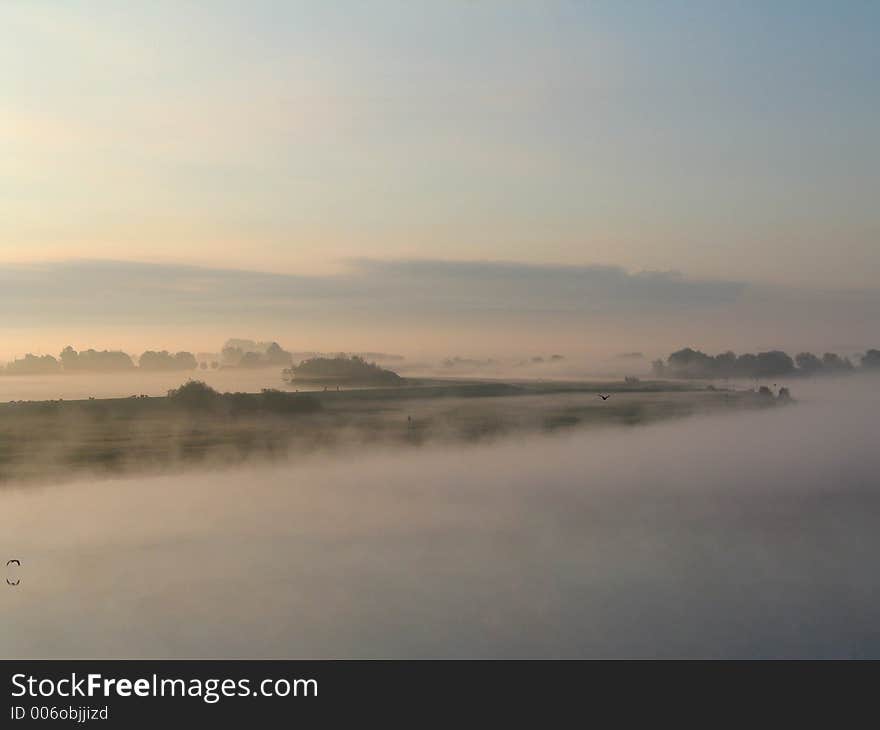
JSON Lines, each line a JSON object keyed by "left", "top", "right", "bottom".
{"left": 0, "top": 260, "right": 745, "bottom": 324}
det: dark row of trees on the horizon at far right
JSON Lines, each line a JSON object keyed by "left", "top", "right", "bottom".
{"left": 651, "top": 347, "right": 880, "bottom": 378}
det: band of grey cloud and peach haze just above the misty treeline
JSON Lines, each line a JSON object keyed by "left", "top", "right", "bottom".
{"left": 0, "top": 259, "right": 880, "bottom": 357}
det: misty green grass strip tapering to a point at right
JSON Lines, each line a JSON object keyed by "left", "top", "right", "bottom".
{"left": 0, "top": 380, "right": 784, "bottom": 483}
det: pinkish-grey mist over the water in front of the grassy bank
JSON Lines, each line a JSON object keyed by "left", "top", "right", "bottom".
{"left": 0, "top": 379, "right": 880, "bottom": 658}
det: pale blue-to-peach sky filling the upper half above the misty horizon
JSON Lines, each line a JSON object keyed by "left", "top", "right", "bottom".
{"left": 0, "top": 0, "right": 880, "bottom": 356}
